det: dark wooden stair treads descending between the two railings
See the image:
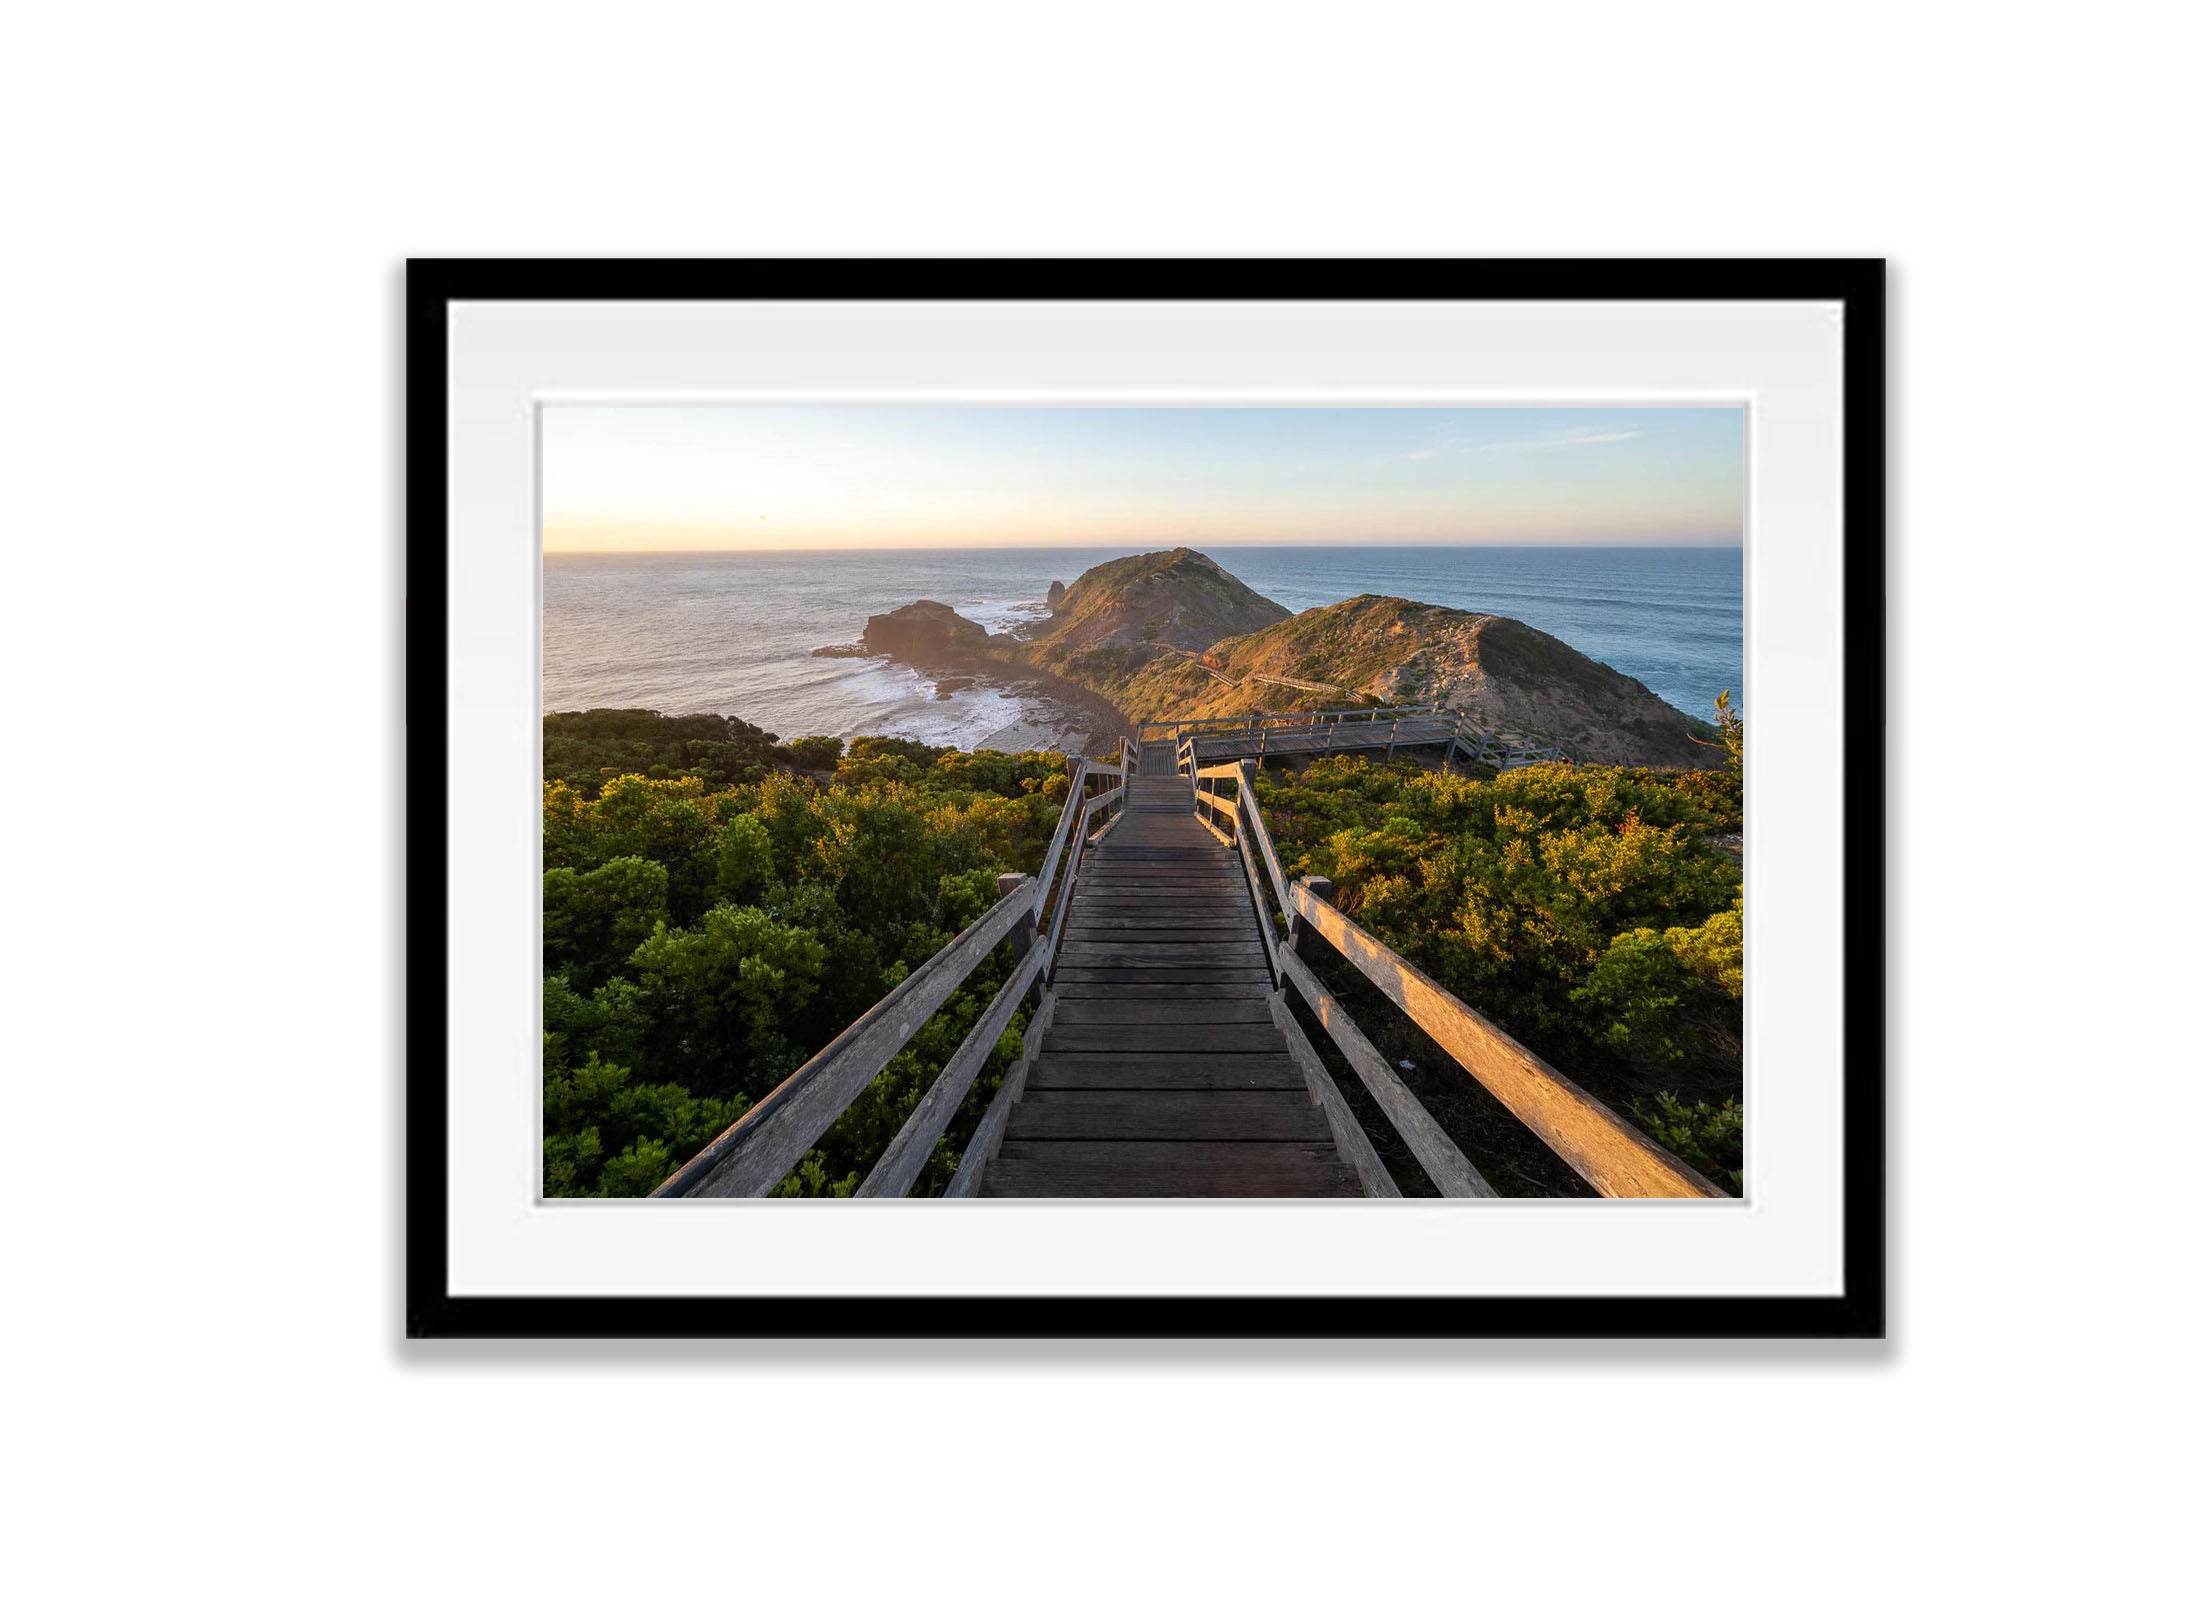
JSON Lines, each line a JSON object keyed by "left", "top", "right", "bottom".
{"left": 977, "top": 742, "right": 1364, "bottom": 1197}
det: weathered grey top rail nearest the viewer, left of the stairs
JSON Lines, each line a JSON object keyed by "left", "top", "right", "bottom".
{"left": 656, "top": 878, "right": 1038, "bottom": 1199}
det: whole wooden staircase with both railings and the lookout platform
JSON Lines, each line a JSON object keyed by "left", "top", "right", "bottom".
{"left": 656, "top": 721, "right": 1723, "bottom": 1199}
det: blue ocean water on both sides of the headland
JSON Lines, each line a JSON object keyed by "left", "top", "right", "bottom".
{"left": 543, "top": 546, "right": 1742, "bottom": 748}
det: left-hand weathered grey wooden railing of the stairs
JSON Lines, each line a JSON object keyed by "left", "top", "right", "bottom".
{"left": 656, "top": 742, "right": 1137, "bottom": 1199}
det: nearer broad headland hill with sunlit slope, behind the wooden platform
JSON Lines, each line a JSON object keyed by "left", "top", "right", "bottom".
{"left": 1118, "top": 594, "right": 1725, "bottom": 768}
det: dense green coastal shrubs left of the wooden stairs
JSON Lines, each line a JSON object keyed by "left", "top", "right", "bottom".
{"left": 543, "top": 711, "right": 1069, "bottom": 1197}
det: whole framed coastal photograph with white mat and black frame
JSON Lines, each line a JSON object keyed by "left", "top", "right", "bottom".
{"left": 407, "top": 260, "right": 1885, "bottom": 1338}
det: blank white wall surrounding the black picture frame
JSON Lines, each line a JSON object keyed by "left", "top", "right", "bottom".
{"left": 0, "top": 2, "right": 2196, "bottom": 1596}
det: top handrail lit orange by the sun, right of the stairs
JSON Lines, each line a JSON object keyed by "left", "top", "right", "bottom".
{"left": 1291, "top": 883, "right": 1725, "bottom": 1199}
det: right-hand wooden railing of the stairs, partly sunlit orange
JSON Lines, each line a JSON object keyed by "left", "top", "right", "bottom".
{"left": 1192, "top": 757, "right": 1725, "bottom": 1199}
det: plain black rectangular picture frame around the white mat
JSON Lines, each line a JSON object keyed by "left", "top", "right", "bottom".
{"left": 405, "top": 260, "right": 1888, "bottom": 1338}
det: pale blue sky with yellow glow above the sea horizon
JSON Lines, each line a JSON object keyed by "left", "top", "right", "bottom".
{"left": 541, "top": 405, "right": 1745, "bottom": 552}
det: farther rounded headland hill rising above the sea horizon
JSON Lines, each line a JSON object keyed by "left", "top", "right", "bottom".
{"left": 1019, "top": 550, "right": 1291, "bottom": 693}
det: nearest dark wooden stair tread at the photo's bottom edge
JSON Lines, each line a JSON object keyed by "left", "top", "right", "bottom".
{"left": 983, "top": 1140, "right": 1360, "bottom": 1199}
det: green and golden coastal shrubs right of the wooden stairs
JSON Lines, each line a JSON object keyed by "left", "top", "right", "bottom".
{"left": 1256, "top": 706, "right": 1742, "bottom": 1193}
